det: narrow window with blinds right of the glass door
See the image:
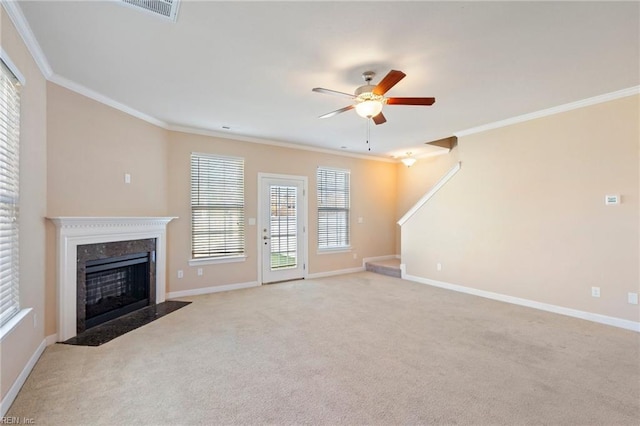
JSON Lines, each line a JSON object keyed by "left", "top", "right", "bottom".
{"left": 317, "top": 167, "right": 350, "bottom": 250}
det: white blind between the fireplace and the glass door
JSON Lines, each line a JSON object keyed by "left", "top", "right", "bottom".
{"left": 191, "top": 153, "right": 245, "bottom": 259}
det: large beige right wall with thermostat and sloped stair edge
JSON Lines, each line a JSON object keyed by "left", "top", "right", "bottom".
{"left": 402, "top": 96, "right": 640, "bottom": 321}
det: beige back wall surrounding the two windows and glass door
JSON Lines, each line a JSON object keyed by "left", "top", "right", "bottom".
{"left": 168, "top": 132, "right": 396, "bottom": 291}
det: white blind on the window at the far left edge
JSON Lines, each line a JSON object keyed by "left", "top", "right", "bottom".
{"left": 0, "top": 61, "right": 20, "bottom": 325}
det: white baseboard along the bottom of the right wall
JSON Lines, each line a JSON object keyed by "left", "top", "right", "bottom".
{"left": 401, "top": 272, "right": 640, "bottom": 333}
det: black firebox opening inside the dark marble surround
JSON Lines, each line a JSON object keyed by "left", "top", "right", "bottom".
{"left": 85, "top": 252, "right": 151, "bottom": 329}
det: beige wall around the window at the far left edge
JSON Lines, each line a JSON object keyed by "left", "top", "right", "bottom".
{"left": 0, "top": 7, "right": 47, "bottom": 398}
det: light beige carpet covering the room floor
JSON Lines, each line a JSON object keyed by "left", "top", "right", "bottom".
{"left": 8, "top": 272, "right": 640, "bottom": 425}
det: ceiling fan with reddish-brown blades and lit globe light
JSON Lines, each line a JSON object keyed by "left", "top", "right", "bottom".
{"left": 313, "top": 70, "right": 436, "bottom": 124}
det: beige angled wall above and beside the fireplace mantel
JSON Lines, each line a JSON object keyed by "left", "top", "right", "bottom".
{"left": 46, "top": 82, "right": 168, "bottom": 335}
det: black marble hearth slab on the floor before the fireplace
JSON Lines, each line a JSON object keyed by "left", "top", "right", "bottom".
{"left": 62, "top": 300, "right": 191, "bottom": 346}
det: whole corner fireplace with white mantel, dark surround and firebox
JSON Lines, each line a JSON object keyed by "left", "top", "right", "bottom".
{"left": 49, "top": 217, "right": 175, "bottom": 342}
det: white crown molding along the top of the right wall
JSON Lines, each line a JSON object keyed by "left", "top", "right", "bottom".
{"left": 454, "top": 86, "right": 640, "bottom": 137}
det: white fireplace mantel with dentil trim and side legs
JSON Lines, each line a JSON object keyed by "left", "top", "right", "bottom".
{"left": 48, "top": 217, "right": 177, "bottom": 342}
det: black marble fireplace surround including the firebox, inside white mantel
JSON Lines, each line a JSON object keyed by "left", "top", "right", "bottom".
{"left": 76, "top": 238, "right": 156, "bottom": 334}
